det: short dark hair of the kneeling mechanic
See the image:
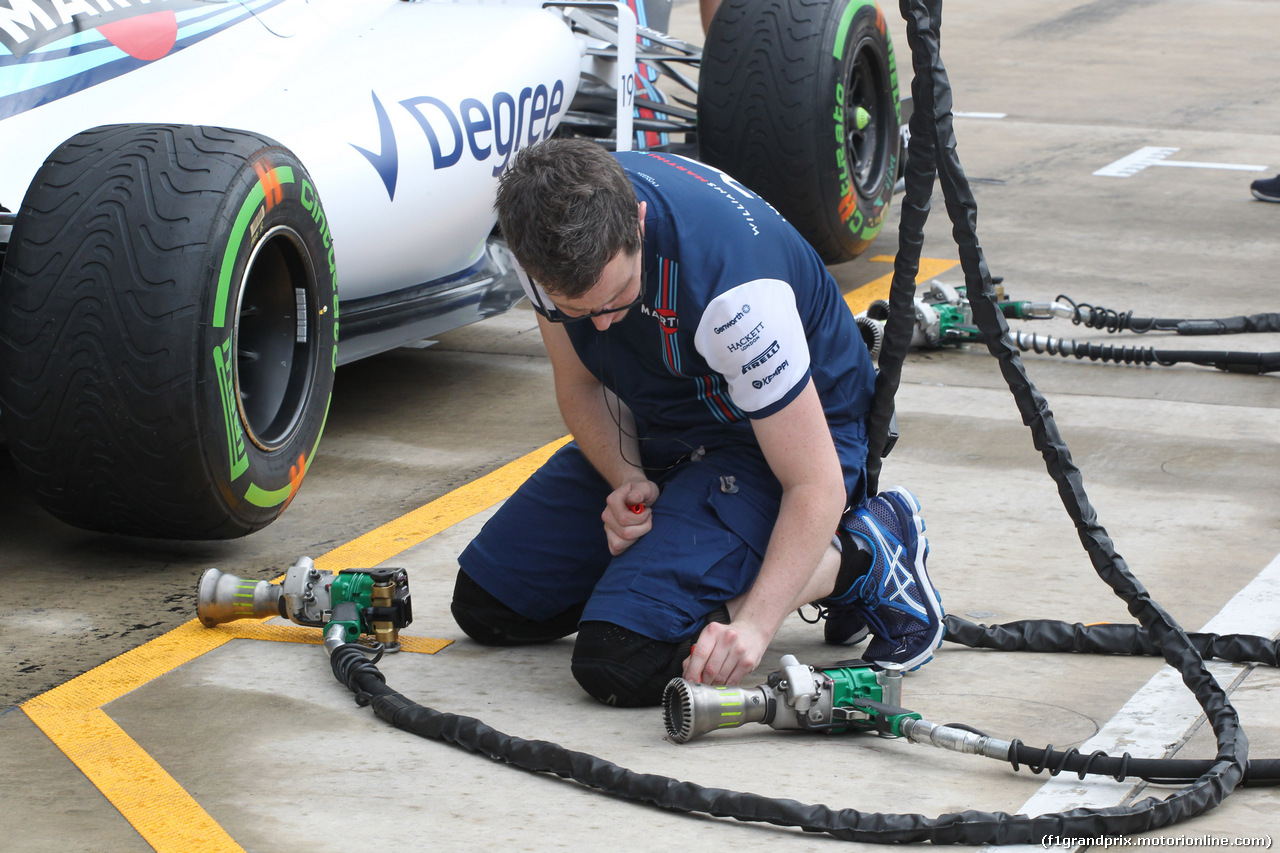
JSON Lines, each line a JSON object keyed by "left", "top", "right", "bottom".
{"left": 494, "top": 140, "right": 640, "bottom": 298}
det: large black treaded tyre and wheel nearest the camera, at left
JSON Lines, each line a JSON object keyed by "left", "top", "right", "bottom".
{"left": 0, "top": 126, "right": 337, "bottom": 539}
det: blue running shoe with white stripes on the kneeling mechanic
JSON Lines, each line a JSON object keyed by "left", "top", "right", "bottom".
{"left": 823, "top": 487, "right": 946, "bottom": 671}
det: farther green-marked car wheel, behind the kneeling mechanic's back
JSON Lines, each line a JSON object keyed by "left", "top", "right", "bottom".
{"left": 698, "top": 0, "right": 901, "bottom": 264}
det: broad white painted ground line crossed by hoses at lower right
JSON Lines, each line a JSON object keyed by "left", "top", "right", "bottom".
{"left": 982, "top": 556, "right": 1280, "bottom": 853}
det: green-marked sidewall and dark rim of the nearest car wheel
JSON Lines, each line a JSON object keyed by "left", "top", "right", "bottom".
{"left": 206, "top": 140, "right": 338, "bottom": 520}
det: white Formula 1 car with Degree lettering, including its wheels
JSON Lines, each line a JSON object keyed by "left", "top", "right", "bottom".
{"left": 0, "top": 0, "right": 901, "bottom": 539}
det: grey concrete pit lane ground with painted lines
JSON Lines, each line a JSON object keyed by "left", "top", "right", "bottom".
{"left": 0, "top": 0, "right": 1280, "bottom": 853}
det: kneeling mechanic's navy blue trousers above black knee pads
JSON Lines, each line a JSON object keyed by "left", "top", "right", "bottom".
{"left": 458, "top": 442, "right": 782, "bottom": 642}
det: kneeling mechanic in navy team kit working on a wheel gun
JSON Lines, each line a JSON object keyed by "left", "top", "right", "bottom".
{"left": 452, "top": 140, "right": 943, "bottom": 706}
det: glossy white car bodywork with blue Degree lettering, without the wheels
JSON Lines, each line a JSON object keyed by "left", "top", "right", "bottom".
{"left": 0, "top": 0, "right": 581, "bottom": 361}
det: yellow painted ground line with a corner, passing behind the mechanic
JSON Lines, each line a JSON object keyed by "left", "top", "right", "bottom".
{"left": 22, "top": 255, "right": 959, "bottom": 853}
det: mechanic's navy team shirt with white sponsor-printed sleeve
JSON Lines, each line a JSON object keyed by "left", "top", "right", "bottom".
{"left": 526, "top": 151, "right": 874, "bottom": 500}
